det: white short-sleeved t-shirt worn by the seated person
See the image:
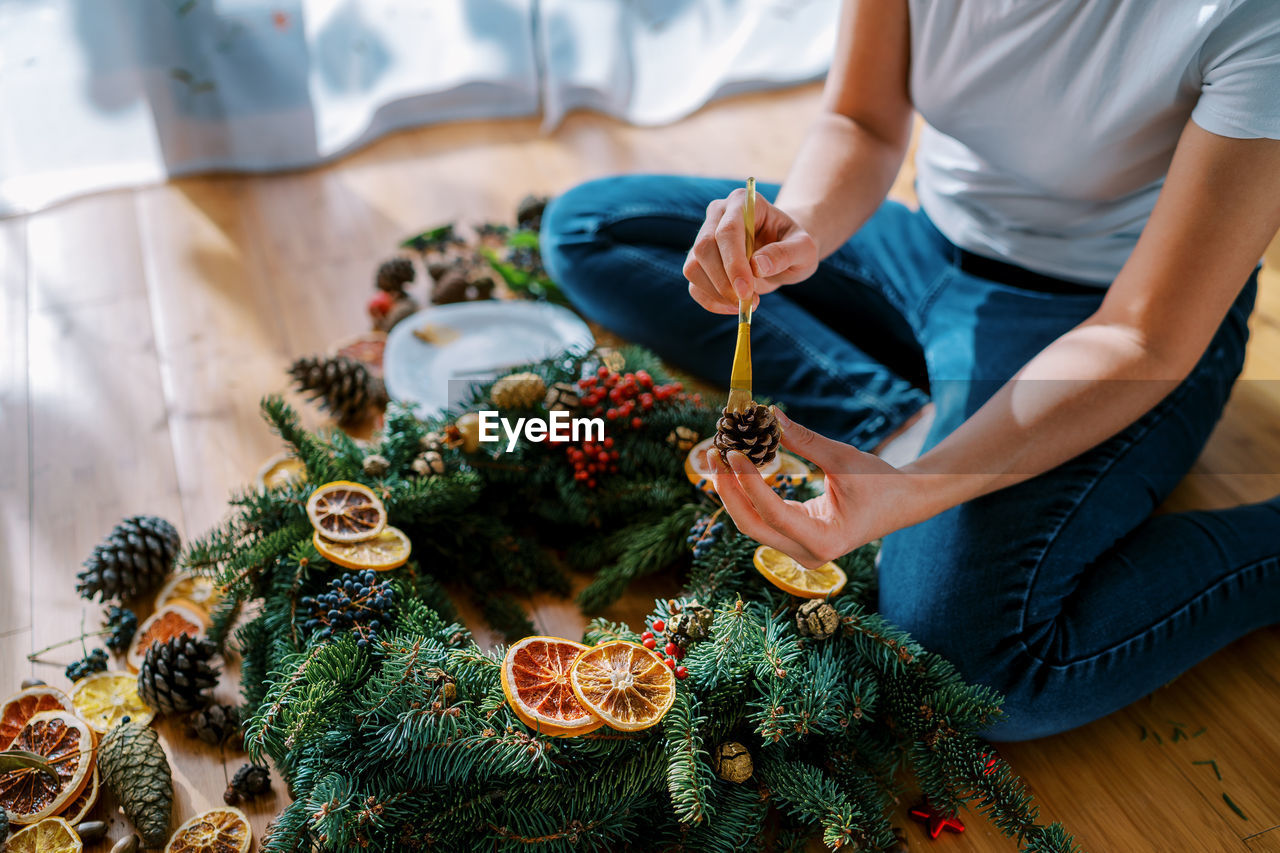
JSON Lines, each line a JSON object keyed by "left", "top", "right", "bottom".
{"left": 909, "top": 0, "right": 1280, "bottom": 284}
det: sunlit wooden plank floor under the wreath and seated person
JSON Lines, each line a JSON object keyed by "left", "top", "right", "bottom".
{"left": 0, "top": 81, "right": 1280, "bottom": 853}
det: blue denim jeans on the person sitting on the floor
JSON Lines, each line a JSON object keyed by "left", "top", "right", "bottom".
{"left": 543, "top": 175, "right": 1280, "bottom": 740}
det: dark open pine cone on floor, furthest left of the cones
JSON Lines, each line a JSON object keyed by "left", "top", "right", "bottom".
{"left": 76, "top": 515, "right": 180, "bottom": 601}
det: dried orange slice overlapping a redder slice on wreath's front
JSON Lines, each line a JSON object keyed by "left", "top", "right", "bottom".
{"left": 568, "top": 640, "right": 676, "bottom": 731}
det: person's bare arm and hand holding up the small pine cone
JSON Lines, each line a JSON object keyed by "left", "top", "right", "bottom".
{"left": 713, "top": 123, "right": 1280, "bottom": 565}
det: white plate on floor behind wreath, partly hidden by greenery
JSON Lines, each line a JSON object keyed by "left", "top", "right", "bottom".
{"left": 383, "top": 300, "right": 595, "bottom": 418}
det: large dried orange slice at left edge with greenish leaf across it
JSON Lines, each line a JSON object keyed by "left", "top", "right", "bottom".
{"left": 0, "top": 711, "right": 93, "bottom": 824}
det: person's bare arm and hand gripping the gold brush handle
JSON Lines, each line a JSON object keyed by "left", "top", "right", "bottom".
{"left": 684, "top": 0, "right": 911, "bottom": 314}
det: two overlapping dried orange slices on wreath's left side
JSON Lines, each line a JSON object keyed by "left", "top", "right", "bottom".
{"left": 307, "top": 480, "right": 412, "bottom": 571}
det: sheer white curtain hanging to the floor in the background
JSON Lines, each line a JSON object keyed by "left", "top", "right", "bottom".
{"left": 0, "top": 0, "right": 837, "bottom": 216}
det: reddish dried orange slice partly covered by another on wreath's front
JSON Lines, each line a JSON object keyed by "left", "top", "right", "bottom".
{"left": 502, "top": 637, "right": 604, "bottom": 738}
